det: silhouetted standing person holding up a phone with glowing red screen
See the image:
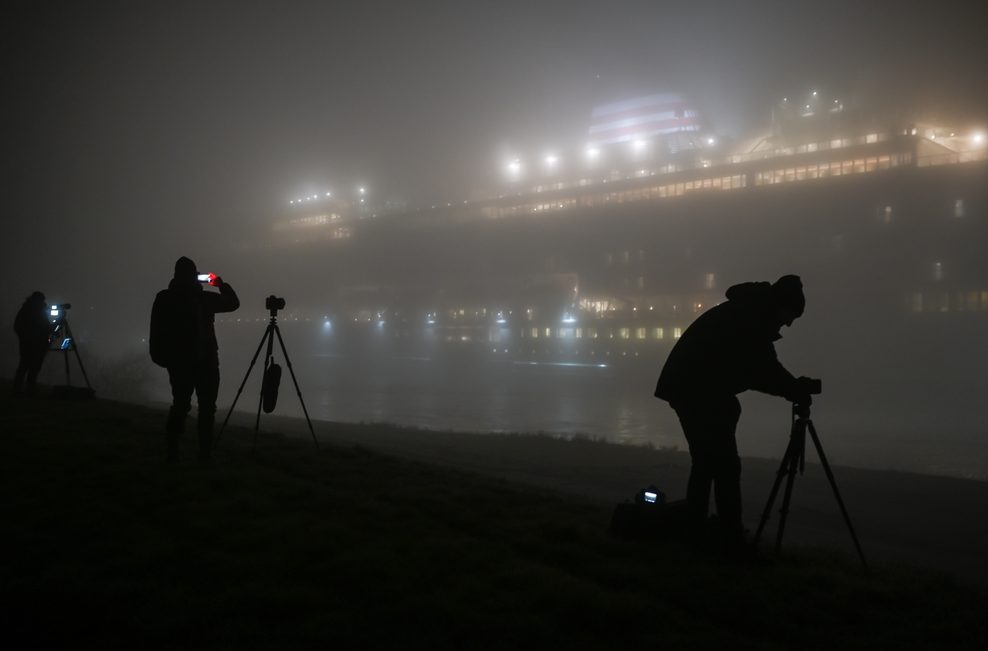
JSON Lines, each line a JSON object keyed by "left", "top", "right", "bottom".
{"left": 148, "top": 256, "right": 240, "bottom": 462}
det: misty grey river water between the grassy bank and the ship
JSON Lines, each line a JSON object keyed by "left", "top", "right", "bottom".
{"left": 206, "top": 324, "right": 988, "bottom": 479}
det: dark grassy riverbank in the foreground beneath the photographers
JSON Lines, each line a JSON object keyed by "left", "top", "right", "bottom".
{"left": 0, "top": 387, "right": 988, "bottom": 649}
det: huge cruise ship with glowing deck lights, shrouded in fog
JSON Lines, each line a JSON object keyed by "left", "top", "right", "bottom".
{"left": 256, "top": 92, "right": 988, "bottom": 365}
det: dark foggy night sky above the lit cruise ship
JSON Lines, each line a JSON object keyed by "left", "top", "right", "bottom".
{"left": 2, "top": 1, "right": 988, "bottom": 336}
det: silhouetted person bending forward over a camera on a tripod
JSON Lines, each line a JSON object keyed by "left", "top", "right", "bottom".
{"left": 655, "top": 275, "right": 814, "bottom": 545}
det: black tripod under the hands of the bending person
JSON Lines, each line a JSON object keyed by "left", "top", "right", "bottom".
{"left": 752, "top": 403, "right": 868, "bottom": 570}
